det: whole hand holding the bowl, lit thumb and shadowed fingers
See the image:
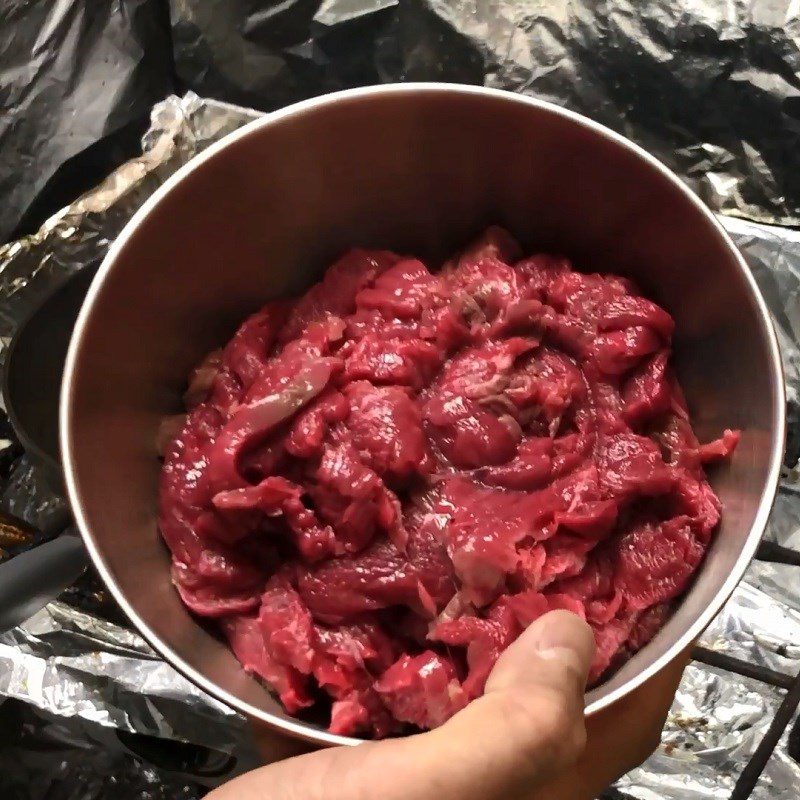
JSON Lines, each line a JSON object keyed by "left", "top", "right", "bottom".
{"left": 207, "top": 611, "right": 688, "bottom": 800}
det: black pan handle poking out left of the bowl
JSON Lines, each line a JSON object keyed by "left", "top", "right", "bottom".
{"left": 0, "top": 531, "right": 89, "bottom": 632}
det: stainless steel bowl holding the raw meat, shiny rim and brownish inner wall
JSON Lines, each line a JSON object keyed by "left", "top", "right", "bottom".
{"left": 61, "top": 84, "right": 784, "bottom": 745}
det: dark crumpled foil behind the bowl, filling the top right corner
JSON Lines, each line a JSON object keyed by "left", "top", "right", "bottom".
{"left": 170, "top": 0, "right": 800, "bottom": 225}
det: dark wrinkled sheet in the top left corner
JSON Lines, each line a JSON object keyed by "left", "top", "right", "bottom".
{"left": 0, "top": 0, "right": 172, "bottom": 241}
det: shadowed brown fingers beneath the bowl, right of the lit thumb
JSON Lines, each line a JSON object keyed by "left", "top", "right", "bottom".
{"left": 532, "top": 647, "right": 691, "bottom": 800}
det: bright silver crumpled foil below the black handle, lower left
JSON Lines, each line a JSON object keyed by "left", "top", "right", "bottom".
{"left": 0, "top": 602, "right": 245, "bottom": 751}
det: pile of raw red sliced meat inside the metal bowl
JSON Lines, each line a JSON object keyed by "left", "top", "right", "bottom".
{"left": 160, "top": 228, "right": 738, "bottom": 737}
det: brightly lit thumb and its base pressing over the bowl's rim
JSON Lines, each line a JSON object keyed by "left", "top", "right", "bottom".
{"left": 207, "top": 611, "right": 594, "bottom": 800}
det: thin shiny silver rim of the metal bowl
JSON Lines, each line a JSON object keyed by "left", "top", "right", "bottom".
{"left": 59, "top": 82, "right": 786, "bottom": 746}
